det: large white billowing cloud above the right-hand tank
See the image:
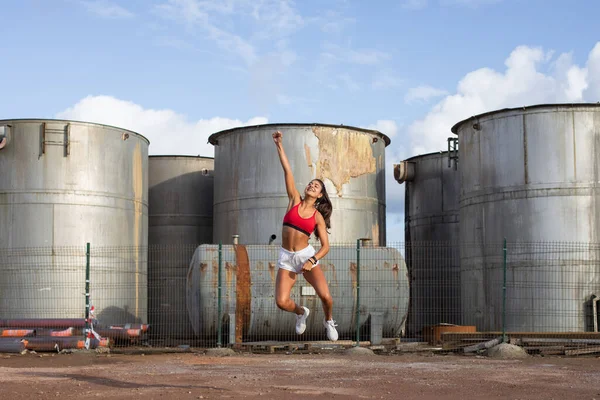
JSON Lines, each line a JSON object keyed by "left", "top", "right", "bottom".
{"left": 408, "top": 42, "right": 600, "bottom": 155}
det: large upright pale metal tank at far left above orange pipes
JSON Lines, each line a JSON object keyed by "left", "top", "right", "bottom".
{"left": 0, "top": 119, "right": 149, "bottom": 324}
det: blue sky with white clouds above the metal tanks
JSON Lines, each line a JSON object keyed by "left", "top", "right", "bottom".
{"left": 0, "top": 0, "right": 600, "bottom": 241}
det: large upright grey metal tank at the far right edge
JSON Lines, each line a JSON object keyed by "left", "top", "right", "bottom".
{"left": 452, "top": 104, "right": 600, "bottom": 332}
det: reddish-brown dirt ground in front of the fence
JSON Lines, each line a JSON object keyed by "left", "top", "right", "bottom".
{"left": 0, "top": 352, "right": 600, "bottom": 400}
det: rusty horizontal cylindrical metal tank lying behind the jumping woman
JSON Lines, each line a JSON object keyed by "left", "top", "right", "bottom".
{"left": 187, "top": 245, "right": 409, "bottom": 343}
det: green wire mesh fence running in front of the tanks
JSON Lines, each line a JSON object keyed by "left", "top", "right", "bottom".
{"left": 0, "top": 241, "right": 600, "bottom": 354}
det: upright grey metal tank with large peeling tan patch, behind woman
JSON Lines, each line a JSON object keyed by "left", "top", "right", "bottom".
{"left": 209, "top": 124, "right": 390, "bottom": 246}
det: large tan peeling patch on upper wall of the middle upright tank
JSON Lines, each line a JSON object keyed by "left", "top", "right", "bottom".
{"left": 312, "top": 126, "right": 376, "bottom": 197}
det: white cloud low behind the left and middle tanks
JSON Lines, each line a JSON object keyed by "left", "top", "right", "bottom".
{"left": 56, "top": 96, "right": 268, "bottom": 157}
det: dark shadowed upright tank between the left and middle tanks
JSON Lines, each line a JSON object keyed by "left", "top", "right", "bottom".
{"left": 148, "top": 156, "right": 214, "bottom": 338}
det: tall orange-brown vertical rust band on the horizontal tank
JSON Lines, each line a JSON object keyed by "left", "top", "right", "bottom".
{"left": 233, "top": 244, "right": 252, "bottom": 343}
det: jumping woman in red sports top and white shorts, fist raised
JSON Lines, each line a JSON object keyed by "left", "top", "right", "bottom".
{"left": 273, "top": 131, "right": 338, "bottom": 341}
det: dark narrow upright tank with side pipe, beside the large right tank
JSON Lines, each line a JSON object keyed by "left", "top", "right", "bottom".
{"left": 394, "top": 151, "right": 461, "bottom": 336}
